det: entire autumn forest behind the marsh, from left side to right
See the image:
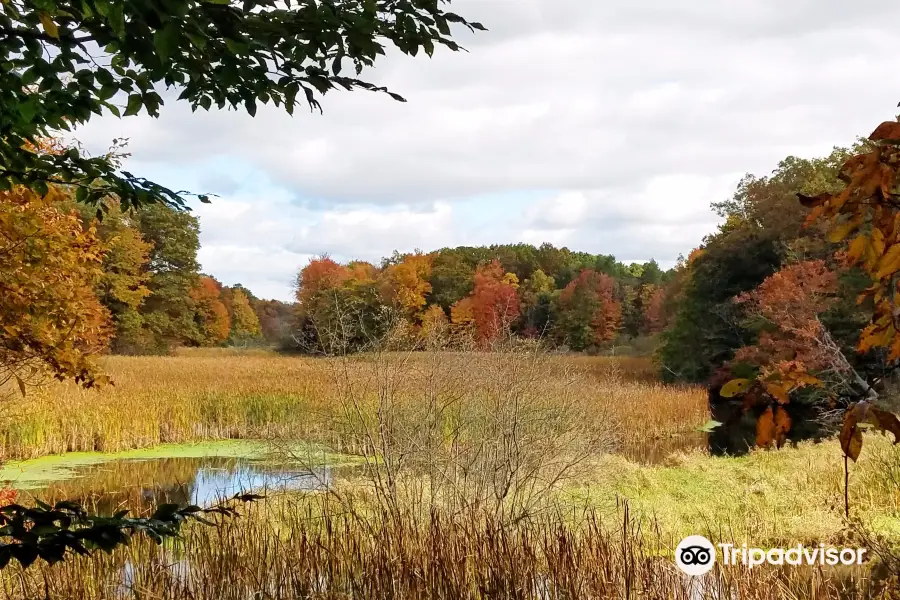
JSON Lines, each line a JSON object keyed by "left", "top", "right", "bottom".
{"left": 0, "top": 137, "right": 886, "bottom": 390}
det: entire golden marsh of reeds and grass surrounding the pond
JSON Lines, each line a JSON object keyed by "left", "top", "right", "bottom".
{"left": 0, "top": 350, "right": 900, "bottom": 600}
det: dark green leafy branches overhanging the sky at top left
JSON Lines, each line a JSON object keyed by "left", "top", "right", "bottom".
{"left": 0, "top": 0, "right": 484, "bottom": 208}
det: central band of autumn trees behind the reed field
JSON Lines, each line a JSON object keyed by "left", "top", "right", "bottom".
{"left": 290, "top": 244, "right": 670, "bottom": 353}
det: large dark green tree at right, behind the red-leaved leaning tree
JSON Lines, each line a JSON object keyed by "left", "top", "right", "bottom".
{"left": 658, "top": 149, "right": 861, "bottom": 382}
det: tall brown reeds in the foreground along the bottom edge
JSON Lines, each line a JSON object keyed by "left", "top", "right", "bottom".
{"left": 0, "top": 500, "right": 890, "bottom": 600}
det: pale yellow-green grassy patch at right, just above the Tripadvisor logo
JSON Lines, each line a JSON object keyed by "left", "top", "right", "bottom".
{"left": 562, "top": 435, "right": 900, "bottom": 547}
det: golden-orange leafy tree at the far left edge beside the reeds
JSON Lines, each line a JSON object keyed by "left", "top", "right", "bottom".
{"left": 0, "top": 187, "right": 111, "bottom": 393}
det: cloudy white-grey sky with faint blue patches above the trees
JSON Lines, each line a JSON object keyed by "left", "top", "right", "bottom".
{"left": 77, "top": 0, "right": 900, "bottom": 300}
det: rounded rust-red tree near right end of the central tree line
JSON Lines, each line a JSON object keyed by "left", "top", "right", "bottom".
{"left": 556, "top": 269, "right": 622, "bottom": 350}
